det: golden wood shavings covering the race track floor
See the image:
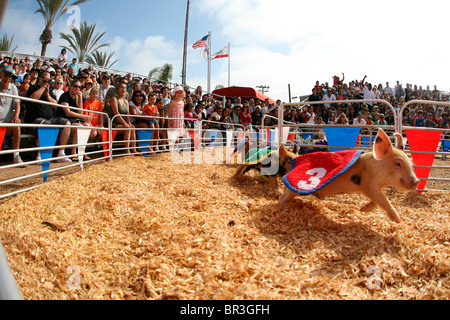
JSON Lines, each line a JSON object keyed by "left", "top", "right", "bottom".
{"left": 0, "top": 154, "right": 450, "bottom": 300}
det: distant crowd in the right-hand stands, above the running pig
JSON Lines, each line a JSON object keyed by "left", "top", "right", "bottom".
{"left": 298, "top": 74, "right": 449, "bottom": 129}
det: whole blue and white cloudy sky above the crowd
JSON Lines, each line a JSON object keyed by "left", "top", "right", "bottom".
{"left": 0, "top": 0, "right": 450, "bottom": 101}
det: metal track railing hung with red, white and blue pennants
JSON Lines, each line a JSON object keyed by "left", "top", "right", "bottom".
{"left": 0, "top": 94, "right": 450, "bottom": 199}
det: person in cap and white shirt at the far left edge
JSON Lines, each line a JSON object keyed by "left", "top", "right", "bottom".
{"left": 0, "top": 65, "right": 23, "bottom": 164}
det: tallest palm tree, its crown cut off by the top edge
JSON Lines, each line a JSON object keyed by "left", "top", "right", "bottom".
{"left": 35, "top": 0, "right": 89, "bottom": 57}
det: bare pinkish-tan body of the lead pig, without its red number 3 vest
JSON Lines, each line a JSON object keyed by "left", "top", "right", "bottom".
{"left": 279, "top": 129, "right": 420, "bottom": 223}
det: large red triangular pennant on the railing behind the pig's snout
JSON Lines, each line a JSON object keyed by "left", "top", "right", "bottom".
{"left": 405, "top": 130, "right": 442, "bottom": 190}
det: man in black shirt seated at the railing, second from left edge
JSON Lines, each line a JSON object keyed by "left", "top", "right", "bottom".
{"left": 25, "top": 71, "right": 72, "bottom": 163}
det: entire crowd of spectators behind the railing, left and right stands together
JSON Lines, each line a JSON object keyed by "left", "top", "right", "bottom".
{"left": 0, "top": 49, "right": 449, "bottom": 163}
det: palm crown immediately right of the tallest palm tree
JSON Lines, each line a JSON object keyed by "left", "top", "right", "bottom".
{"left": 59, "top": 21, "right": 109, "bottom": 63}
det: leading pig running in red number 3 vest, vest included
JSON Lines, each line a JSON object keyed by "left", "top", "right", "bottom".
{"left": 279, "top": 129, "right": 420, "bottom": 223}
